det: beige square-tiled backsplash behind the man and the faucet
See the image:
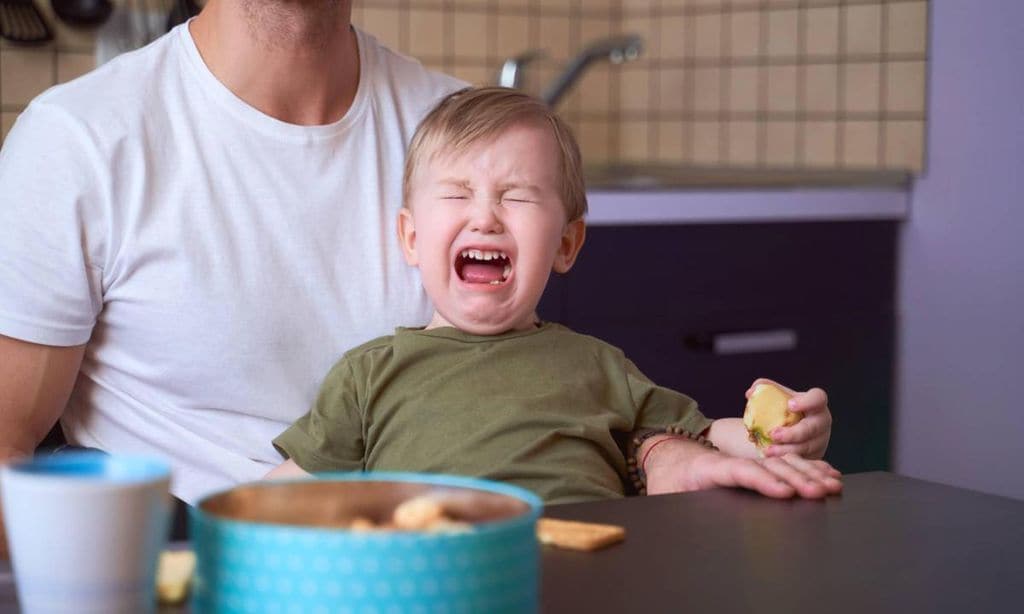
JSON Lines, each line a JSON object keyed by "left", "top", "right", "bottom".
{"left": 0, "top": 0, "right": 928, "bottom": 171}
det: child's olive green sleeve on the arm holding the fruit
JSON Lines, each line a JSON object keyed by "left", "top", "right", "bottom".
{"left": 626, "top": 359, "right": 712, "bottom": 435}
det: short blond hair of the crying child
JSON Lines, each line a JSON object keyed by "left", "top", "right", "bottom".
{"left": 401, "top": 87, "right": 587, "bottom": 222}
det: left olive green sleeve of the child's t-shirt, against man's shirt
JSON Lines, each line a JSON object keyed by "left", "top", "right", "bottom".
{"left": 273, "top": 357, "right": 365, "bottom": 473}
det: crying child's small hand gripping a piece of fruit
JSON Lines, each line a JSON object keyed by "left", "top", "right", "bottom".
{"left": 746, "top": 378, "right": 831, "bottom": 459}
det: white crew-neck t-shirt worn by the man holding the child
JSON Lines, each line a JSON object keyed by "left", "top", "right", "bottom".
{"left": 0, "top": 26, "right": 464, "bottom": 502}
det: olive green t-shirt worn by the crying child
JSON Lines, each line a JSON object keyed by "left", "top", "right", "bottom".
{"left": 273, "top": 323, "right": 711, "bottom": 503}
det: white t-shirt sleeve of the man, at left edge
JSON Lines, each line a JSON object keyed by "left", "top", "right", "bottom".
{"left": 0, "top": 102, "right": 110, "bottom": 346}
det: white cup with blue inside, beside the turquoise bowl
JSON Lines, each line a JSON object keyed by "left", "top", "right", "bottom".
{"left": 0, "top": 452, "right": 171, "bottom": 614}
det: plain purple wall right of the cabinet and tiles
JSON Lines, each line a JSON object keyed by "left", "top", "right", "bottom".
{"left": 895, "top": 0, "right": 1024, "bottom": 498}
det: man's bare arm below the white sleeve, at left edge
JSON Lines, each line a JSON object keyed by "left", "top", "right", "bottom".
{"left": 0, "top": 335, "right": 85, "bottom": 463}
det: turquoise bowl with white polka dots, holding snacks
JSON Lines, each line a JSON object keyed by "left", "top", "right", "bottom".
{"left": 190, "top": 473, "right": 542, "bottom": 614}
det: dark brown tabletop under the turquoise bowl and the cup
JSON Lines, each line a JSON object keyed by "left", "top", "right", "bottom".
{"left": 0, "top": 473, "right": 1024, "bottom": 614}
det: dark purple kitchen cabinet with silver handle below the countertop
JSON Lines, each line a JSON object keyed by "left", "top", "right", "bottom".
{"left": 540, "top": 221, "right": 898, "bottom": 473}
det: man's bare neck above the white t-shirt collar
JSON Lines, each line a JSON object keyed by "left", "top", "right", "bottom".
{"left": 189, "top": 0, "right": 359, "bottom": 126}
